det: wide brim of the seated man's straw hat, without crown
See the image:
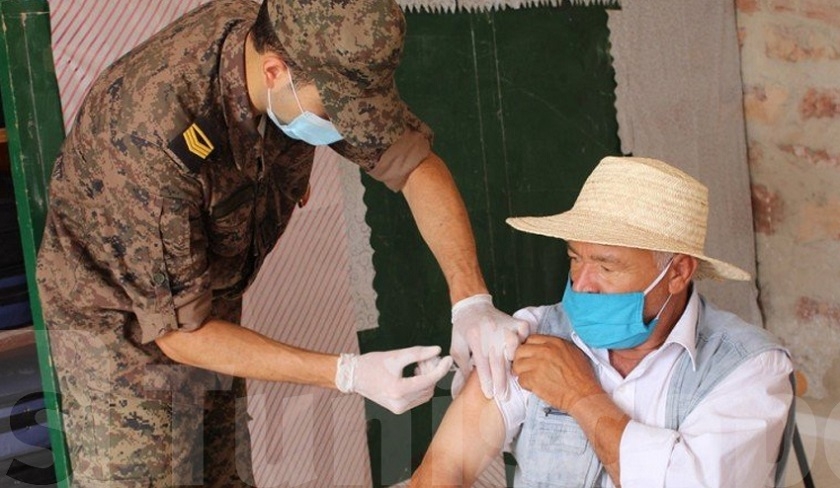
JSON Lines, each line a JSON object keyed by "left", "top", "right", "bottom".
{"left": 505, "top": 214, "right": 751, "bottom": 281}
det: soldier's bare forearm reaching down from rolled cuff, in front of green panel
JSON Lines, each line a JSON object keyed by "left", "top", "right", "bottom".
{"left": 402, "top": 153, "right": 487, "bottom": 303}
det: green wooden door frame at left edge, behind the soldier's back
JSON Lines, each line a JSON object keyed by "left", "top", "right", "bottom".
{"left": 0, "top": 0, "right": 70, "bottom": 487}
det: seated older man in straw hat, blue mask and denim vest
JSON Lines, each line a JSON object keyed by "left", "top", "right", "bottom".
{"left": 412, "top": 157, "right": 792, "bottom": 488}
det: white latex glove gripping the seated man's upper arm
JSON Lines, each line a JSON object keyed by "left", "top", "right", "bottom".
{"left": 449, "top": 294, "right": 530, "bottom": 400}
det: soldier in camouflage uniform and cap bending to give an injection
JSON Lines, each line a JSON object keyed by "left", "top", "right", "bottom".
{"left": 38, "top": 0, "right": 524, "bottom": 487}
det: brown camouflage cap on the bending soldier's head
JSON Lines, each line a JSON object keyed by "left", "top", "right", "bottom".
{"left": 266, "top": 0, "right": 431, "bottom": 156}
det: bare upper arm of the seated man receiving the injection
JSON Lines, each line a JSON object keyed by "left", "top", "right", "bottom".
{"left": 410, "top": 373, "right": 505, "bottom": 488}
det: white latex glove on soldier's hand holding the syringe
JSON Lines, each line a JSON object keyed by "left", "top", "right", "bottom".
{"left": 335, "top": 346, "right": 452, "bottom": 414}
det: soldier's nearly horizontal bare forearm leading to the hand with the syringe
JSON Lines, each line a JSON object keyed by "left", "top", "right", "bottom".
{"left": 155, "top": 319, "right": 338, "bottom": 388}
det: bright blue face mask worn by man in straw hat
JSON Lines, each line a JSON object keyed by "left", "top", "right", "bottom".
{"left": 563, "top": 262, "right": 671, "bottom": 349}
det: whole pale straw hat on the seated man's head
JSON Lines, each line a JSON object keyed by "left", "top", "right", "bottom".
{"left": 506, "top": 156, "right": 750, "bottom": 281}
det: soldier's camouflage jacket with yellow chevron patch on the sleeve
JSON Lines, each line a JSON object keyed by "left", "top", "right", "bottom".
{"left": 38, "top": 0, "right": 431, "bottom": 396}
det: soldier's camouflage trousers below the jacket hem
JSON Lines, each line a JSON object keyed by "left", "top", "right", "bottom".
{"left": 59, "top": 356, "right": 254, "bottom": 487}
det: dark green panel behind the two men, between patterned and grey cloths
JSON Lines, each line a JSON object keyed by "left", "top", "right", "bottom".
{"left": 360, "top": 3, "right": 620, "bottom": 485}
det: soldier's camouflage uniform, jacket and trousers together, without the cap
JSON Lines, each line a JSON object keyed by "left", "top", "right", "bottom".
{"left": 31, "top": 0, "right": 430, "bottom": 486}
